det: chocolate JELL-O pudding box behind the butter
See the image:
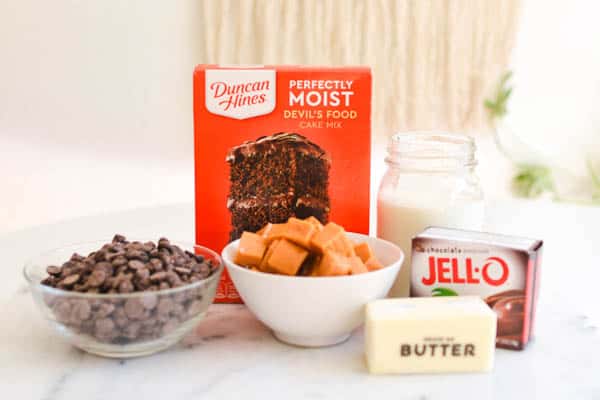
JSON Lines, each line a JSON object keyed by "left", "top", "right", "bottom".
{"left": 411, "top": 227, "right": 543, "bottom": 350}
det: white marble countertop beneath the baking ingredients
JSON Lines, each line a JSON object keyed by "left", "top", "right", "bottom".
{"left": 0, "top": 202, "right": 600, "bottom": 400}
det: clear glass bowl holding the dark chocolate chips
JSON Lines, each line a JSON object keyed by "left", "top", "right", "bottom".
{"left": 23, "top": 241, "right": 223, "bottom": 358}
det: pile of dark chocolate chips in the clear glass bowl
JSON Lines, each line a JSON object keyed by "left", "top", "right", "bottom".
{"left": 42, "top": 235, "right": 218, "bottom": 344}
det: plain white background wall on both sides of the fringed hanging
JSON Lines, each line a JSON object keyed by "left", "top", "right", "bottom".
{"left": 0, "top": 0, "right": 600, "bottom": 233}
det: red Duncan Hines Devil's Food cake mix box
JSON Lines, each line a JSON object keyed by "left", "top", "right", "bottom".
{"left": 194, "top": 65, "right": 371, "bottom": 303}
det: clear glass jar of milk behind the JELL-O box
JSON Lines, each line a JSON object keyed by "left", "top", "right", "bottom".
{"left": 377, "top": 132, "right": 484, "bottom": 297}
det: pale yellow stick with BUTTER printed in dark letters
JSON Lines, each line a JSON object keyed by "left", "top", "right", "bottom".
{"left": 365, "top": 296, "right": 496, "bottom": 374}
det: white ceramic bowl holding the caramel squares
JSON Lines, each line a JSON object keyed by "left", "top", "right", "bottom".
{"left": 222, "top": 233, "right": 404, "bottom": 347}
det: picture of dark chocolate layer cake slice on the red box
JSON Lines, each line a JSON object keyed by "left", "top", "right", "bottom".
{"left": 226, "top": 133, "right": 331, "bottom": 240}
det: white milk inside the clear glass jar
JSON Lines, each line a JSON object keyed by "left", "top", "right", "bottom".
{"left": 377, "top": 196, "right": 484, "bottom": 297}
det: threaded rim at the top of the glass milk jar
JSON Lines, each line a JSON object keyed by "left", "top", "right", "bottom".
{"left": 386, "top": 131, "right": 477, "bottom": 167}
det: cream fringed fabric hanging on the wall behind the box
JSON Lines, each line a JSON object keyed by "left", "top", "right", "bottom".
{"left": 200, "top": 0, "right": 520, "bottom": 143}
